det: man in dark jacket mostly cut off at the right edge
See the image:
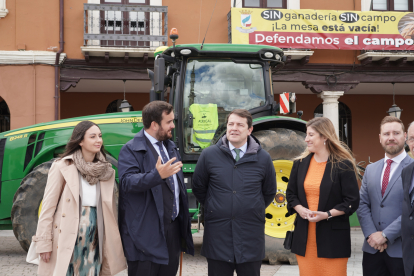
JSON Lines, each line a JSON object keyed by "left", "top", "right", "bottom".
{"left": 401, "top": 122, "right": 414, "bottom": 276}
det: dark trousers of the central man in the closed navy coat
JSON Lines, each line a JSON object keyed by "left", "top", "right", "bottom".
{"left": 207, "top": 259, "right": 262, "bottom": 276}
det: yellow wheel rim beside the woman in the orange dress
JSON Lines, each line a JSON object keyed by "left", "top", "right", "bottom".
{"left": 265, "top": 160, "right": 296, "bottom": 238}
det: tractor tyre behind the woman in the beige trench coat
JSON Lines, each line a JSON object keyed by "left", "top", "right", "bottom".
{"left": 11, "top": 154, "right": 119, "bottom": 251}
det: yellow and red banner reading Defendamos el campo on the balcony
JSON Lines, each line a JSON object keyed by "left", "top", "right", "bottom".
{"left": 231, "top": 8, "right": 414, "bottom": 50}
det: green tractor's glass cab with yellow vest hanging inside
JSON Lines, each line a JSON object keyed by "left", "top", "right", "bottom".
{"left": 149, "top": 36, "right": 283, "bottom": 161}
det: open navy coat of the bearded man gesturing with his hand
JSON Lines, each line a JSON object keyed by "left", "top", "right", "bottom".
{"left": 118, "top": 130, "right": 194, "bottom": 265}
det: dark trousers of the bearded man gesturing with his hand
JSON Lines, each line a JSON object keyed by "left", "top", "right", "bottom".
{"left": 128, "top": 219, "right": 181, "bottom": 276}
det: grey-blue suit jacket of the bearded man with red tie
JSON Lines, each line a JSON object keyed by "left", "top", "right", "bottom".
{"left": 357, "top": 155, "right": 413, "bottom": 258}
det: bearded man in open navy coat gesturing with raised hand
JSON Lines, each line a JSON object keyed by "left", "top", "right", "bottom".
{"left": 117, "top": 101, "right": 194, "bottom": 276}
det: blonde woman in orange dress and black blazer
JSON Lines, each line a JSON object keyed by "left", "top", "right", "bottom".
{"left": 286, "top": 117, "right": 359, "bottom": 276}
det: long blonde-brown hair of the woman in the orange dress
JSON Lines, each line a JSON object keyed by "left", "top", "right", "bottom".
{"left": 295, "top": 117, "right": 358, "bottom": 179}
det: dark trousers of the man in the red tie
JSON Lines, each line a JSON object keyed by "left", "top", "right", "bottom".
{"left": 362, "top": 251, "right": 404, "bottom": 276}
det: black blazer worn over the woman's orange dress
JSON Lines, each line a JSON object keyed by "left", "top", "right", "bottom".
{"left": 286, "top": 154, "right": 359, "bottom": 258}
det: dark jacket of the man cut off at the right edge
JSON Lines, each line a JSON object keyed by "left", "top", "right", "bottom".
{"left": 401, "top": 163, "right": 414, "bottom": 275}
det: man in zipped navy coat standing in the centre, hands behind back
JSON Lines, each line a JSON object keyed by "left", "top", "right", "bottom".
{"left": 192, "top": 109, "right": 276, "bottom": 276}
